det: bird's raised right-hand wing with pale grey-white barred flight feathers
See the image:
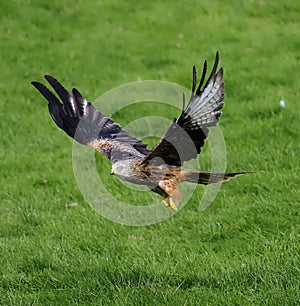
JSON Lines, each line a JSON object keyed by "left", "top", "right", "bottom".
{"left": 141, "top": 52, "right": 224, "bottom": 166}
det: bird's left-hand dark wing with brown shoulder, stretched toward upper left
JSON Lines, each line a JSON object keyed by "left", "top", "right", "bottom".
{"left": 31, "top": 75, "right": 150, "bottom": 162}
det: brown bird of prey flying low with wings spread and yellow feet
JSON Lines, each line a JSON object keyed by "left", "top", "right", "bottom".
{"left": 32, "top": 52, "right": 245, "bottom": 210}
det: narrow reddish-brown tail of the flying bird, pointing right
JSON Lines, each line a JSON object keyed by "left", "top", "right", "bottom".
{"left": 181, "top": 169, "right": 248, "bottom": 185}
